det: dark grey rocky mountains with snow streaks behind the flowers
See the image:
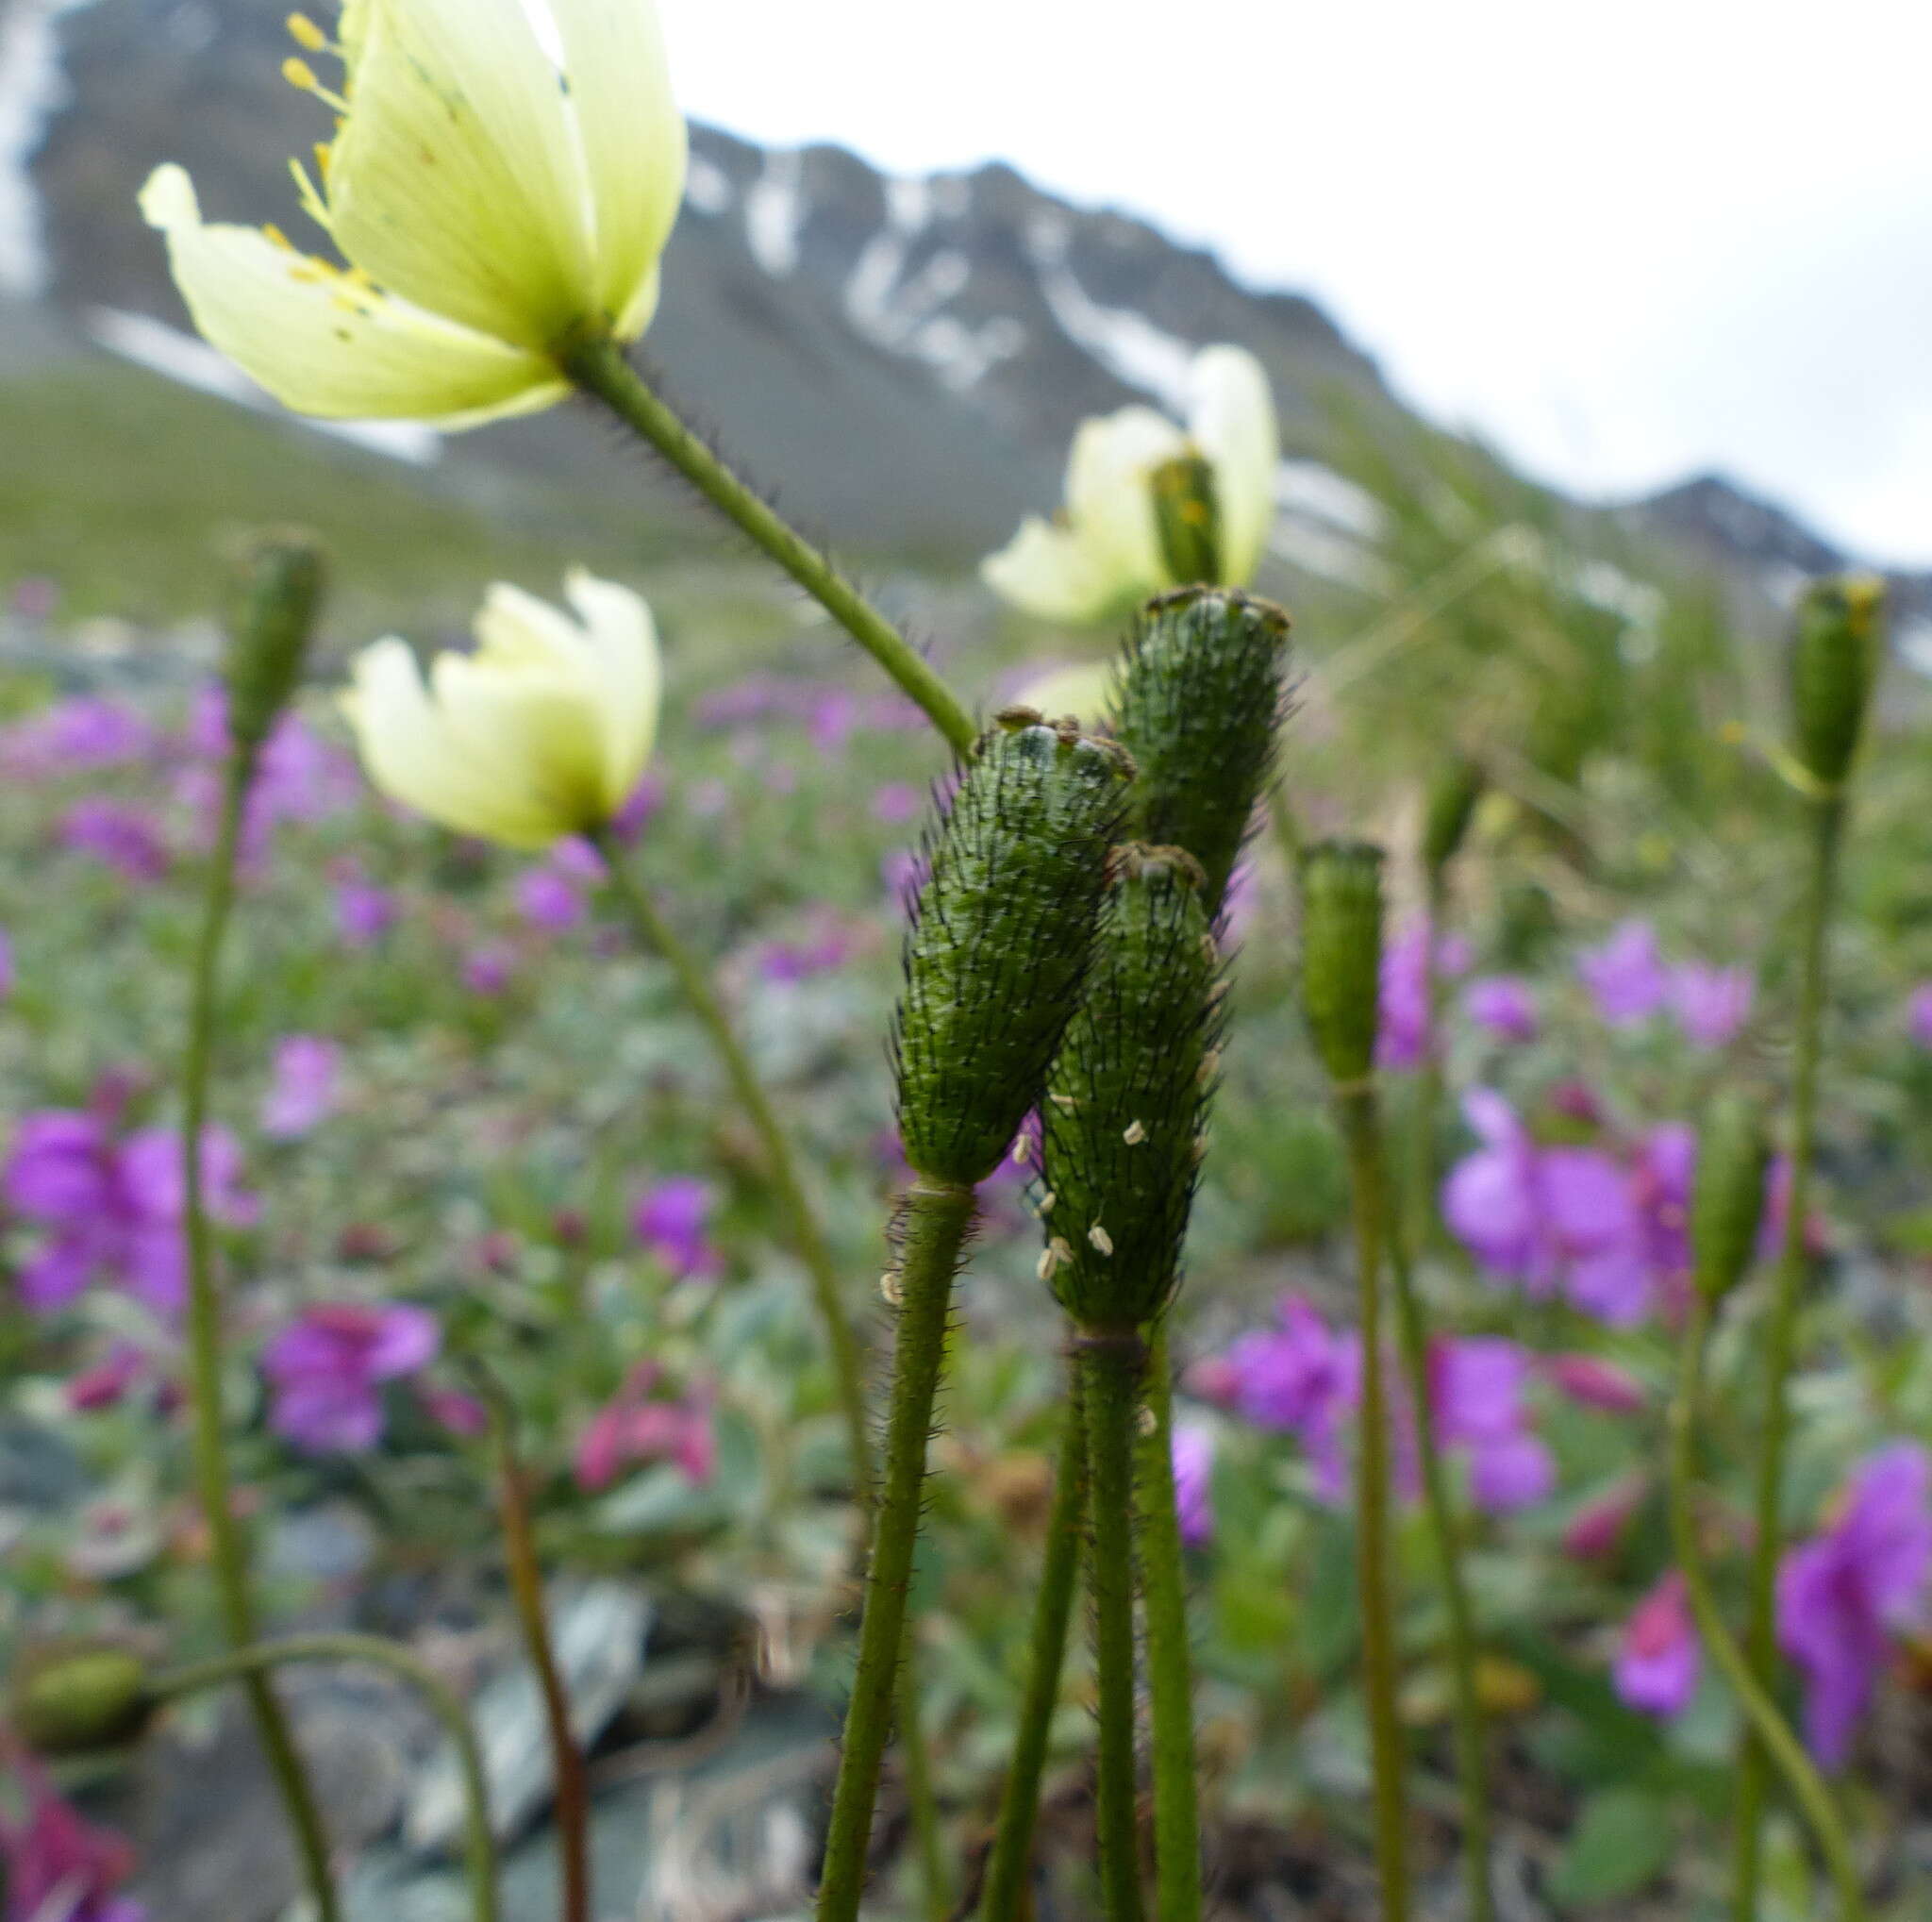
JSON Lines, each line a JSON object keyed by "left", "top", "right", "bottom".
{"left": 0, "top": 0, "right": 1932, "bottom": 629}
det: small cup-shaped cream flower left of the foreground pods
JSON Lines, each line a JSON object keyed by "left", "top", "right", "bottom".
{"left": 341, "top": 570, "right": 660, "bottom": 848}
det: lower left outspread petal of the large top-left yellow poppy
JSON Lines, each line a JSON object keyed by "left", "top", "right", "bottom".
{"left": 142, "top": 166, "right": 566, "bottom": 426}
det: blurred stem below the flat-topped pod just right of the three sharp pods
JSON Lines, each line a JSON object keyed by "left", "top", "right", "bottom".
{"left": 1337, "top": 1088, "right": 1408, "bottom": 1922}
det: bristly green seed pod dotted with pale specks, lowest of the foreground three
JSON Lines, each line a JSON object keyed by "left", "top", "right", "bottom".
{"left": 1040, "top": 844, "right": 1221, "bottom": 1329}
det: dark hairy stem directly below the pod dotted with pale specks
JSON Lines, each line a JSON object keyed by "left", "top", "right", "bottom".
{"left": 1074, "top": 1329, "right": 1136, "bottom": 1922}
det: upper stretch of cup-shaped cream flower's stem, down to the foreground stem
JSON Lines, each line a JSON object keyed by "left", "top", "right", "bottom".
{"left": 597, "top": 830, "right": 872, "bottom": 1497}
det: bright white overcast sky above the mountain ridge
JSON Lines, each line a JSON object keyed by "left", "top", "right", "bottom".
{"left": 660, "top": 0, "right": 1932, "bottom": 564}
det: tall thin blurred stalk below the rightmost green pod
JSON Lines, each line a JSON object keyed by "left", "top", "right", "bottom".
{"left": 1731, "top": 792, "right": 1845, "bottom": 1922}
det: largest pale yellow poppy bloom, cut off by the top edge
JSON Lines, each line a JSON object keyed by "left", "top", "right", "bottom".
{"left": 142, "top": 0, "right": 686, "bottom": 426}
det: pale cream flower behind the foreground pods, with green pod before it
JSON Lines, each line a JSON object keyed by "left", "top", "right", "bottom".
{"left": 979, "top": 348, "right": 1281, "bottom": 622}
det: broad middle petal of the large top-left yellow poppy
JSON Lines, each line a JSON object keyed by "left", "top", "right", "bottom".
{"left": 328, "top": 0, "right": 591, "bottom": 350}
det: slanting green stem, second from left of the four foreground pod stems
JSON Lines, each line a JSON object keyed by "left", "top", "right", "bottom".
{"left": 979, "top": 1376, "right": 1086, "bottom": 1922}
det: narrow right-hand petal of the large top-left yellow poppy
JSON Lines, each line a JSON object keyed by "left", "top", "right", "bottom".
{"left": 551, "top": 0, "right": 688, "bottom": 340}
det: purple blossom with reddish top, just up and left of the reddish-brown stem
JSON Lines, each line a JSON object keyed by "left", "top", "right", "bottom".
{"left": 260, "top": 1302, "right": 442, "bottom": 1455}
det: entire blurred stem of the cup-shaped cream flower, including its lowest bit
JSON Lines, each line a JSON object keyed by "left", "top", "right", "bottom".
{"left": 595, "top": 832, "right": 951, "bottom": 1922}
